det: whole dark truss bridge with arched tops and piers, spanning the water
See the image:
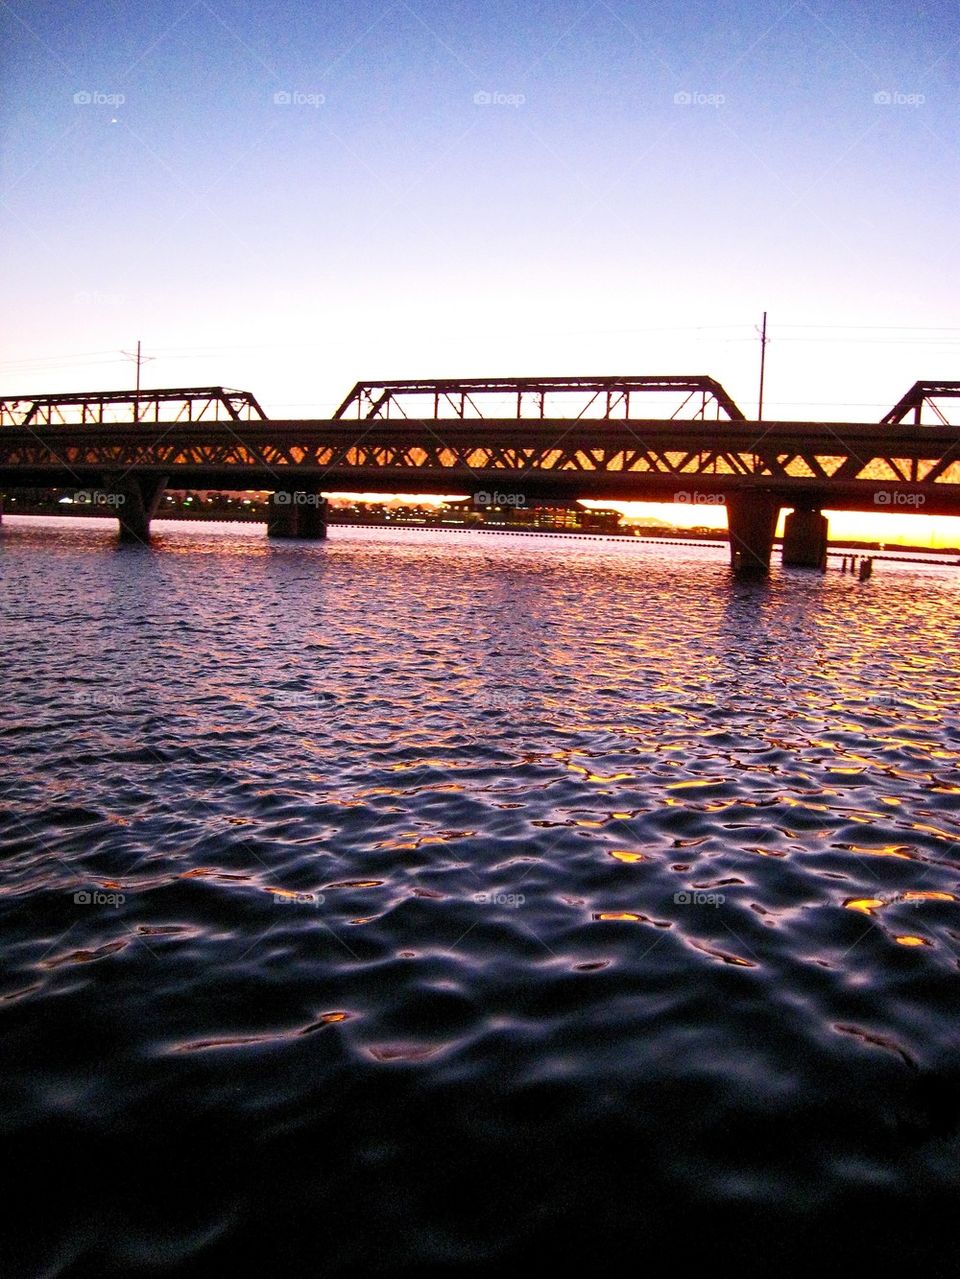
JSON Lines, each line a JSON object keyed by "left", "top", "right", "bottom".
{"left": 0, "top": 375, "right": 960, "bottom": 574}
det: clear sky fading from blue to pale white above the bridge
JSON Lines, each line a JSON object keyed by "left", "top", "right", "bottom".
{"left": 0, "top": 0, "right": 960, "bottom": 542}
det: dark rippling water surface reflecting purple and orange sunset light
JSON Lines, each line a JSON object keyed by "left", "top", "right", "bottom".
{"left": 0, "top": 518, "right": 960, "bottom": 1279}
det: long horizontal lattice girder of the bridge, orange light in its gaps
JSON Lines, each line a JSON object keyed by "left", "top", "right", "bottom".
{"left": 0, "top": 418, "right": 960, "bottom": 504}
